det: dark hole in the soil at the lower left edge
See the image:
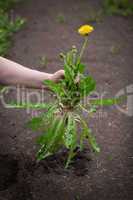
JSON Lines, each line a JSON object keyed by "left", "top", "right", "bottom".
{"left": 0, "top": 155, "right": 18, "bottom": 191}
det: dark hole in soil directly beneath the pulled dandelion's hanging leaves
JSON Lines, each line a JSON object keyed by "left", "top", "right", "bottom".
{"left": 39, "top": 149, "right": 91, "bottom": 176}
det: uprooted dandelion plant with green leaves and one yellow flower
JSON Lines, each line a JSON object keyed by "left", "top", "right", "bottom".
{"left": 10, "top": 25, "right": 118, "bottom": 168}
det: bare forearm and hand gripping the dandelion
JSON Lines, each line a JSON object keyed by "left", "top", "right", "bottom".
{"left": 0, "top": 57, "right": 64, "bottom": 89}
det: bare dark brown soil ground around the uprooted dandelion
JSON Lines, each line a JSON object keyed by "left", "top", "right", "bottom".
{"left": 0, "top": 0, "right": 133, "bottom": 200}
